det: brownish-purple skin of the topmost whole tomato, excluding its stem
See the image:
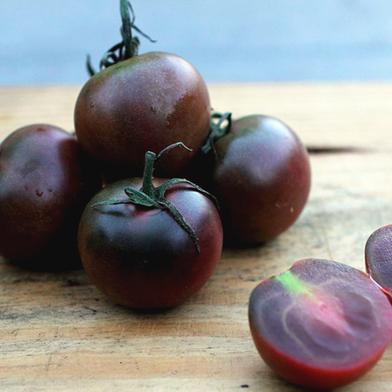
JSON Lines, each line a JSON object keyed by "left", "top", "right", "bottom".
{"left": 75, "top": 52, "right": 210, "bottom": 178}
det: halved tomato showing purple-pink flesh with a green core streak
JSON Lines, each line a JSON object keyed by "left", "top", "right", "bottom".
{"left": 249, "top": 259, "right": 392, "bottom": 390}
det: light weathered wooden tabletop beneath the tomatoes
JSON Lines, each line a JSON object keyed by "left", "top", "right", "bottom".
{"left": 0, "top": 84, "right": 392, "bottom": 392}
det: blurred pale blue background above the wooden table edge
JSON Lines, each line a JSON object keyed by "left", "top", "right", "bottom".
{"left": 0, "top": 0, "right": 392, "bottom": 85}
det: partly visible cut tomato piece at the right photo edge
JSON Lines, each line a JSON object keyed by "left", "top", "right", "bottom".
{"left": 365, "top": 225, "right": 392, "bottom": 302}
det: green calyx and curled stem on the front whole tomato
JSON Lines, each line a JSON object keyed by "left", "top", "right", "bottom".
{"left": 93, "top": 142, "right": 217, "bottom": 253}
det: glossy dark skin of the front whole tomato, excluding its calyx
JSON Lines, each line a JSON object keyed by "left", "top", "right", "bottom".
{"left": 79, "top": 179, "right": 223, "bottom": 310}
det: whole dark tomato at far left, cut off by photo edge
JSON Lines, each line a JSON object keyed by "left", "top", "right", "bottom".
{"left": 0, "top": 124, "right": 99, "bottom": 269}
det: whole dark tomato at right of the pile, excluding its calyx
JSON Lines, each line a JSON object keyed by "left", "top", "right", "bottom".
{"left": 211, "top": 115, "right": 310, "bottom": 244}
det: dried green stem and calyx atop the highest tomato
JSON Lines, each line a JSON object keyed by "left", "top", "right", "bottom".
{"left": 86, "top": 0, "right": 156, "bottom": 76}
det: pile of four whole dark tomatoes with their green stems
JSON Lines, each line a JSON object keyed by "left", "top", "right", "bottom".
{"left": 0, "top": 0, "right": 310, "bottom": 309}
